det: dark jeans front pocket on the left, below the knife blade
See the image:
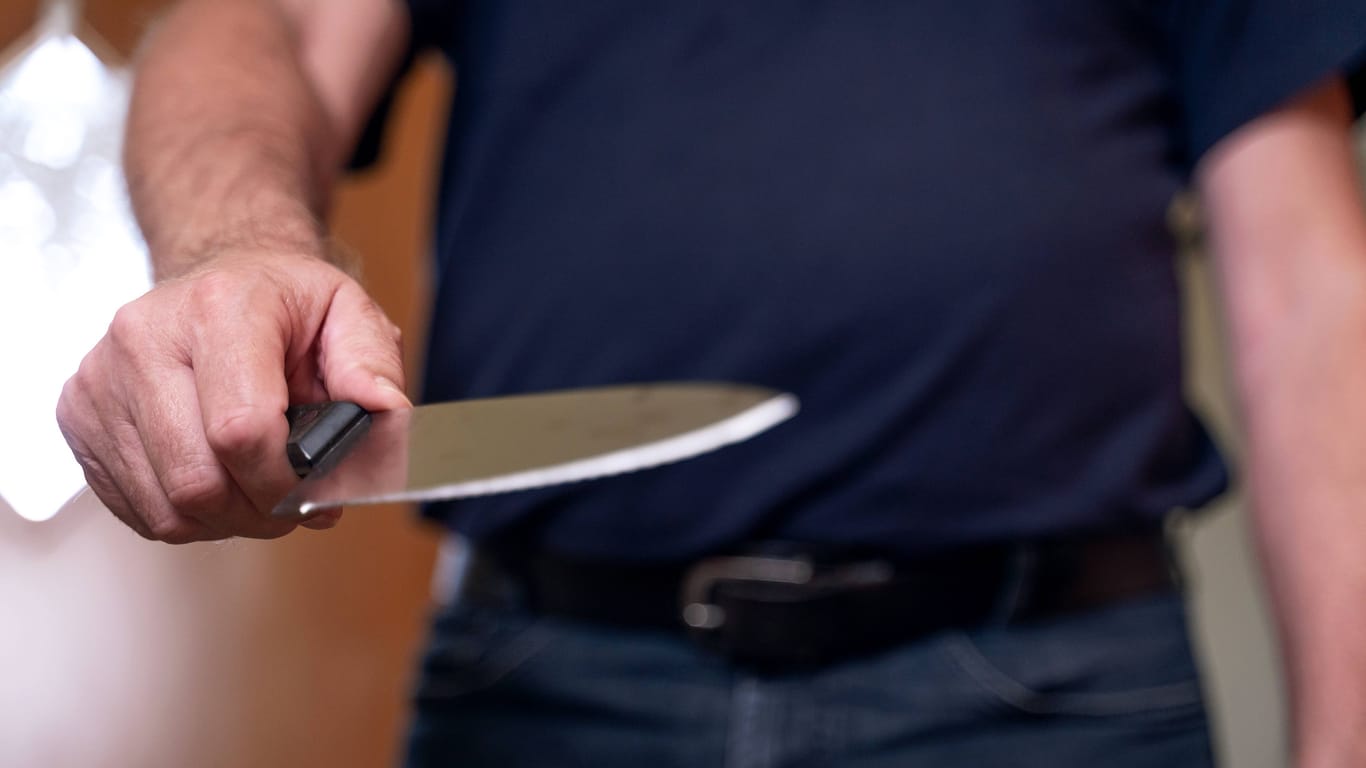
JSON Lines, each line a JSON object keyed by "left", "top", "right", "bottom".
{"left": 415, "top": 603, "right": 550, "bottom": 705}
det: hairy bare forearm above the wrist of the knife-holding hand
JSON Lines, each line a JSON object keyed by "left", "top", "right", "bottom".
{"left": 126, "top": 0, "right": 402, "bottom": 276}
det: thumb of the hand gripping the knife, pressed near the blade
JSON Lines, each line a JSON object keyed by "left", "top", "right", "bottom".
{"left": 318, "top": 282, "right": 413, "bottom": 411}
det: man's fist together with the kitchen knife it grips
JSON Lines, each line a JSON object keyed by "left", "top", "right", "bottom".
{"left": 57, "top": 245, "right": 796, "bottom": 543}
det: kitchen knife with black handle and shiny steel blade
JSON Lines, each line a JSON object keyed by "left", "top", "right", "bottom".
{"left": 273, "top": 383, "right": 798, "bottom": 518}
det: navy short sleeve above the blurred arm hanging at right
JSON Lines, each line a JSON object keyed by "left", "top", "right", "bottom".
{"left": 1172, "top": 0, "right": 1366, "bottom": 168}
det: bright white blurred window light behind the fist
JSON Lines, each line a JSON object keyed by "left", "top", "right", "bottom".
{"left": 0, "top": 17, "right": 150, "bottom": 521}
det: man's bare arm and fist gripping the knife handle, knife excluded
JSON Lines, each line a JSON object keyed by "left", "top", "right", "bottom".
{"left": 57, "top": 0, "right": 407, "bottom": 543}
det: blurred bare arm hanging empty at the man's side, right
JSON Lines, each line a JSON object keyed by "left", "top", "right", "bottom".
{"left": 1197, "top": 78, "right": 1366, "bottom": 768}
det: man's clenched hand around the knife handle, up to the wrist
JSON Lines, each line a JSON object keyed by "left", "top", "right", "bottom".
{"left": 57, "top": 253, "right": 408, "bottom": 543}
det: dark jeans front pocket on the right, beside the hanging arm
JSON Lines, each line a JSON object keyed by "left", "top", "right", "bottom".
{"left": 943, "top": 596, "right": 1205, "bottom": 717}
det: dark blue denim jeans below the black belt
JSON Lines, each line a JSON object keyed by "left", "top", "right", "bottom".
{"left": 407, "top": 584, "right": 1212, "bottom": 768}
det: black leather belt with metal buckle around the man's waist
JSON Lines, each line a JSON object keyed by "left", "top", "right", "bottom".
{"left": 456, "top": 530, "right": 1179, "bottom": 670}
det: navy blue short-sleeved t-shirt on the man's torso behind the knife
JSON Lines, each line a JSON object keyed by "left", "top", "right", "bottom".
{"left": 368, "top": 0, "right": 1366, "bottom": 559}
